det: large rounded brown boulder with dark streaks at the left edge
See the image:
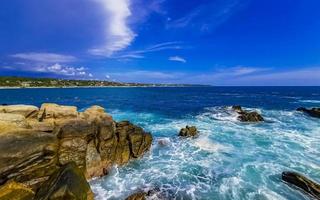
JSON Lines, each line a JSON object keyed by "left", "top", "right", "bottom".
{"left": 0, "top": 130, "right": 58, "bottom": 187}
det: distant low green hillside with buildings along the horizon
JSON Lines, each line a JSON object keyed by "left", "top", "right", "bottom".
{"left": 0, "top": 77, "right": 210, "bottom": 88}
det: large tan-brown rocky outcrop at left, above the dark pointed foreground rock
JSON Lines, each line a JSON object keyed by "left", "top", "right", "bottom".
{"left": 0, "top": 104, "right": 152, "bottom": 198}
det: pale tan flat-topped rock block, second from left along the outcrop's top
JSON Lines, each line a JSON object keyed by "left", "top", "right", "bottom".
{"left": 38, "top": 103, "right": 78, "bottom": 121}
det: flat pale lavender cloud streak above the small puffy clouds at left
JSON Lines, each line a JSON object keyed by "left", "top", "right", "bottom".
{"left": 11, "top": 52, "right": 77, "bottom": 63}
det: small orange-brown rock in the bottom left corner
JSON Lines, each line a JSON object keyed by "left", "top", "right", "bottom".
{"left": 0, "top": 181, "right": 34, "bottom": 200}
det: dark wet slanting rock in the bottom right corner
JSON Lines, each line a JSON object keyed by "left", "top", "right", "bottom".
{"left": 282, "top": 172, "right": 320, "bottom": 199}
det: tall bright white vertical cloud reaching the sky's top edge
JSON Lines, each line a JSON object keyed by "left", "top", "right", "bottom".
{"left": 89, "top": 0, "right": 136, "bottom": 57}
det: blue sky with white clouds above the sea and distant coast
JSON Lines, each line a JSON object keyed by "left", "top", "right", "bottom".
{"left": 0, "top": 0, "right": 320, "bottom": 85}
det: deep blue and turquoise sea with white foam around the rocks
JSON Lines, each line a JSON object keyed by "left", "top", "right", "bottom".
{"left": 0, "top": 87, "right": 320, "bottom": 200}
